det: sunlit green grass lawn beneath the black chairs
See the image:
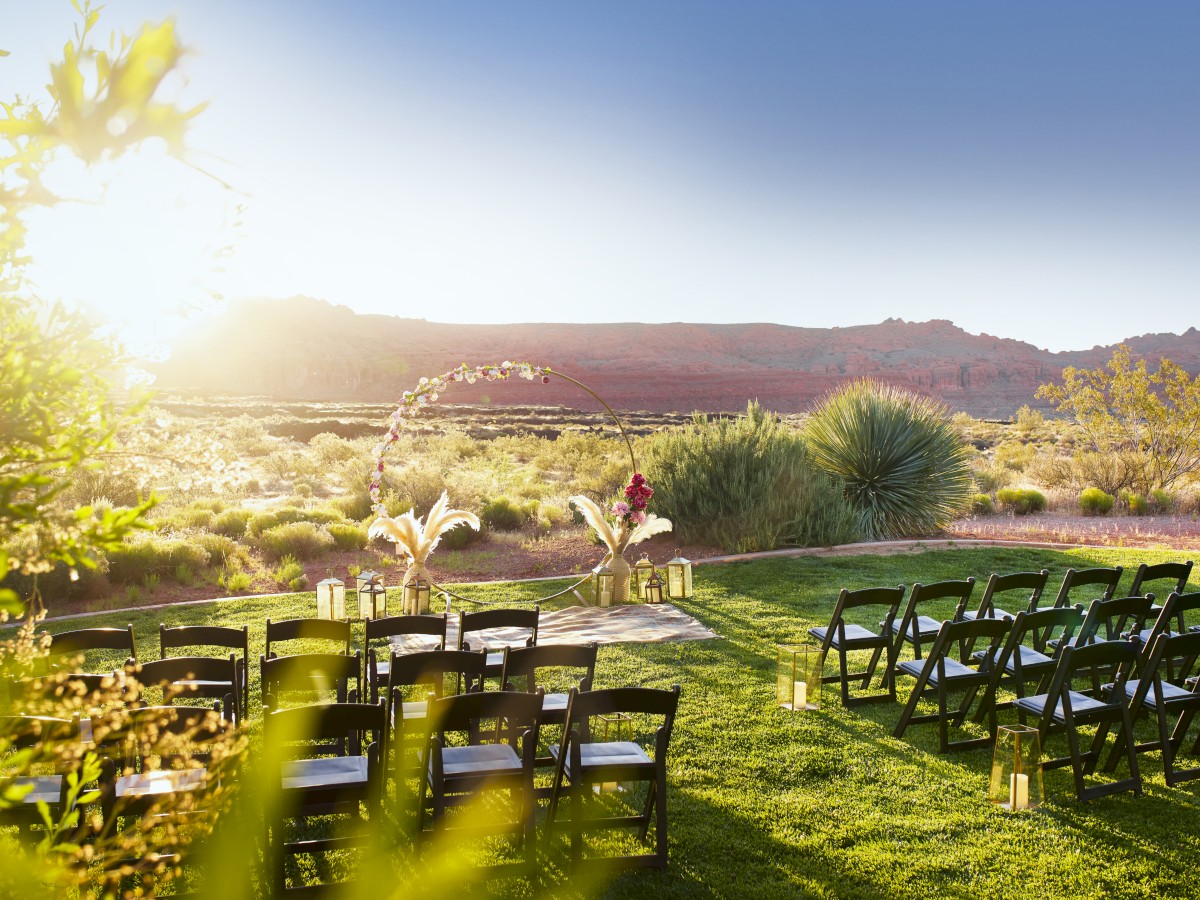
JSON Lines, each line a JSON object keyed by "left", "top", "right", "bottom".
{"left": 25, "top": 548, "right": 1200, "bottom": 898}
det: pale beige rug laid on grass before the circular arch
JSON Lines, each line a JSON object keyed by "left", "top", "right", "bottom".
{"left": 392, "top": 604, "right": 720, "bottom": 650}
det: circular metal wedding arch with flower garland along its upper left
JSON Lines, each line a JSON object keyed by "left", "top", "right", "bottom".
{"left": 371, "top": 361, "right": 637, "bottom": 610}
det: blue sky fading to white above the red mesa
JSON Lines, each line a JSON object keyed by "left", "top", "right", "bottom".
{"left": 0, "top": 0, "right": 1200, "bottom": 349}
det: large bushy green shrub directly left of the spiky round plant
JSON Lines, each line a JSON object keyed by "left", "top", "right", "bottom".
{"left": 644, "top": 402, "right": 862, "bottom": 551}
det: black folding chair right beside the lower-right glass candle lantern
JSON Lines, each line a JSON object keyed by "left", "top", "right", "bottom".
{"left": 1016, "top": 643, "right": 1141, "bottom": 800}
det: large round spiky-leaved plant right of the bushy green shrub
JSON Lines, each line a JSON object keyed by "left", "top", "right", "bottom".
{"left": 804, "top": 379, "right": 971, "bottom": 540}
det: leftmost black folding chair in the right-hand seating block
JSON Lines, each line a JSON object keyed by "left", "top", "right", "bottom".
{"left": 809, "top": 584, "right": 905, "bottom": 707}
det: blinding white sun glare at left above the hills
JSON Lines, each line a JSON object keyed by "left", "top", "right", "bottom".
{"left": 28, "top": 146, "right": 234, "bottom": 356}
